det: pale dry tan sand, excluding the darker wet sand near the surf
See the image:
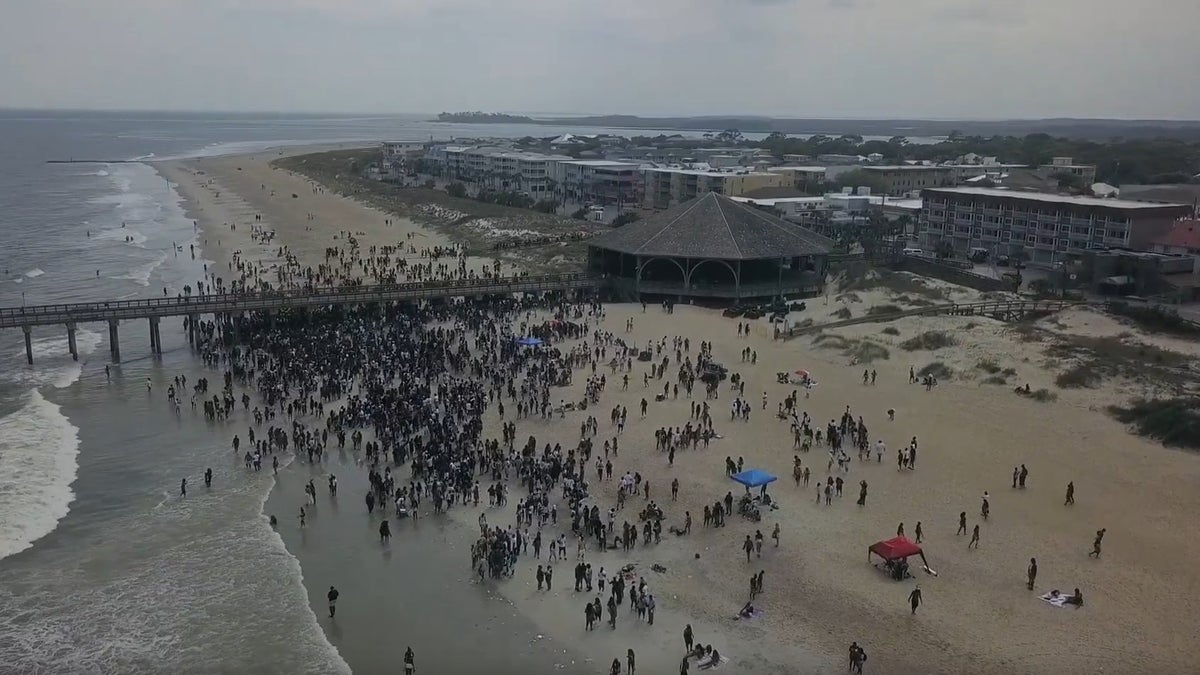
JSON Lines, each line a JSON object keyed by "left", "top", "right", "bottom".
{"left": 163, "top": 154, "right": 1200, "bottom": 674}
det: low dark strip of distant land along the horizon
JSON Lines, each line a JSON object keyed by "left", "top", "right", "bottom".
{"left": 437, "top": 112, "right": 1200, "bottom": 141}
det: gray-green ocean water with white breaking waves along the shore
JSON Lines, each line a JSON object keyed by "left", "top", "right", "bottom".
{"left": 0, "top": 112, "right": 676, "bottom": 674}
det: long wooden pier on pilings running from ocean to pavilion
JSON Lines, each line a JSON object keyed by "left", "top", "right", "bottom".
{"left": 0, "top": 274, "right": 599, "bottom": 364}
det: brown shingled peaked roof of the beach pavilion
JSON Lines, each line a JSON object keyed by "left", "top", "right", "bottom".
{"left": 589, "top": 192, "right": 833, "bottom": 261}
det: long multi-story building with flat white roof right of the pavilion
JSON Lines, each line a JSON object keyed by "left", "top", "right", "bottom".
{"left": 917, "top": 187, "right": 1192, "bottom": 264}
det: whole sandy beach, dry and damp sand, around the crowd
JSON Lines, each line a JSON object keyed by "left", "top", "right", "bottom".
{"left": 156, "top": 148, "right": 1200, "bottom": 674}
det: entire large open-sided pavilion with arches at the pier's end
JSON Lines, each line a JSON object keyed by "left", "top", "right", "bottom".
{"left": 588, "top": 192, "right": 833, "bottom": 301}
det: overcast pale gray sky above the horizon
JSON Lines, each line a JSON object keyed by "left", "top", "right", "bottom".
{"left": 0, "top": 0, "right": 1200, "bottom": 119}
